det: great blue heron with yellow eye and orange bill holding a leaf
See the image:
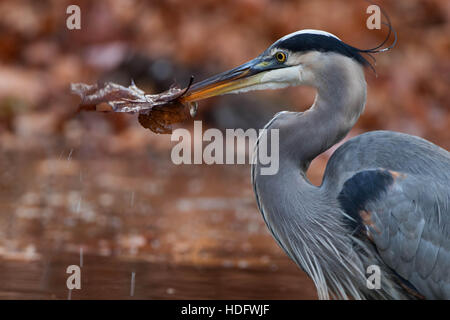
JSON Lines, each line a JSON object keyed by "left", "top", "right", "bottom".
{"left": 184, "top": 30, "right": 450, "bottom": 299}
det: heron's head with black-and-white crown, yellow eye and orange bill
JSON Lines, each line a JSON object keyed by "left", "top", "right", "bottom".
{"left": 183, "top": 30, "right": 368, "bottom": 102}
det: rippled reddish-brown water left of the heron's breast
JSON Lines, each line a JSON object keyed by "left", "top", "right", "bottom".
{"left": 0, "top": 134, "right": 316, "bottom": 299}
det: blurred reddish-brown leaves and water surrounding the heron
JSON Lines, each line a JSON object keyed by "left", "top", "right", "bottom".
{"left": 0, "top": 0, "right": 450, "bottom": 299}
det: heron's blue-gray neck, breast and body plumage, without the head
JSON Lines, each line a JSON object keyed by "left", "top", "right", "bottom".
{"left": 252, "top": 54, "right": 450, "bottom": 299}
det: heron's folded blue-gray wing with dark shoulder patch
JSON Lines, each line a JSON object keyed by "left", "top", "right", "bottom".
{"left": 338, "top": 169, "right": 450, "bottom": 299}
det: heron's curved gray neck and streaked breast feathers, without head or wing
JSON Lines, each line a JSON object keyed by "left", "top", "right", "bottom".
{"left": 252, "top": 55, "right": 408, "bottom": 299}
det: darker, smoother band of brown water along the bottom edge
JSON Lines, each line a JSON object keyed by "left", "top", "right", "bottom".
{"left": 0, "top": 253, "right": 314, "bottom": 299}
